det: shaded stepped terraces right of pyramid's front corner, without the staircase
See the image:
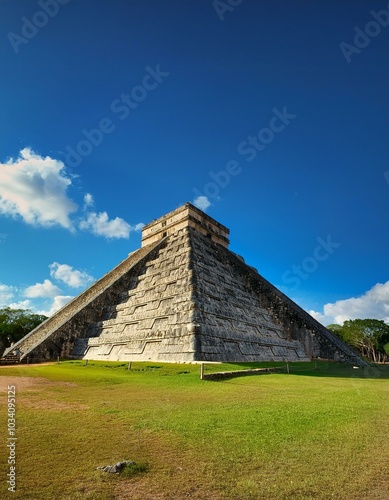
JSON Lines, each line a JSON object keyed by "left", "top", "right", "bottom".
{"left": 189, "top": 230, "right": 308, "bottom": 361}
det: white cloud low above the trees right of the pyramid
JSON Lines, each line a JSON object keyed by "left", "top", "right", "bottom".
{"left": 309, "top": 281, "right": 389, "bottom": 325}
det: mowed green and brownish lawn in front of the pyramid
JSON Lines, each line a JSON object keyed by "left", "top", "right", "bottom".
{"left": 0, "top": 361, "right": 389, "bottom": 500}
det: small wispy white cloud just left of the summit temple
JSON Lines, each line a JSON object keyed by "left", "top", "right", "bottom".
{"left": 80, "top": 212, "right": 144, "bottom": 238}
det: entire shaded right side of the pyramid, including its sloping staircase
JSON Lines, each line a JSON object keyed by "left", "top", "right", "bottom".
{"left": 191, "top": 231, "right": 366, "bottom": 365}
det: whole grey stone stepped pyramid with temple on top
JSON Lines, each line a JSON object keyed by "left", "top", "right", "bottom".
{"left": 5, "top": 203, "right": 364, "bottom": 365}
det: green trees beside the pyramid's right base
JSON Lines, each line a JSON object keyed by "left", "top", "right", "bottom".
{"left": 327, "top": 319, "right": 389, "bottom": 363}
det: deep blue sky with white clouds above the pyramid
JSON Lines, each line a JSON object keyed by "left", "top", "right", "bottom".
{"left": 0, "top": 0, "right": 389, "bottom": 324}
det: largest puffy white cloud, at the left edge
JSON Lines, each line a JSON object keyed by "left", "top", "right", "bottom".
{"left": 0, "top": 148, "right": 77, "bottom": 230}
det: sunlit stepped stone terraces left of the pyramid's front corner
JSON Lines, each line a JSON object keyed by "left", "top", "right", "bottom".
{"left": 81, "top": 229, "right": 196, "bottom": 362}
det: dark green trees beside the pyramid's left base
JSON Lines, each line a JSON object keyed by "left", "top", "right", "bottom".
{"left": 0, "top": 307, "right": 47, "bottom": 352}
